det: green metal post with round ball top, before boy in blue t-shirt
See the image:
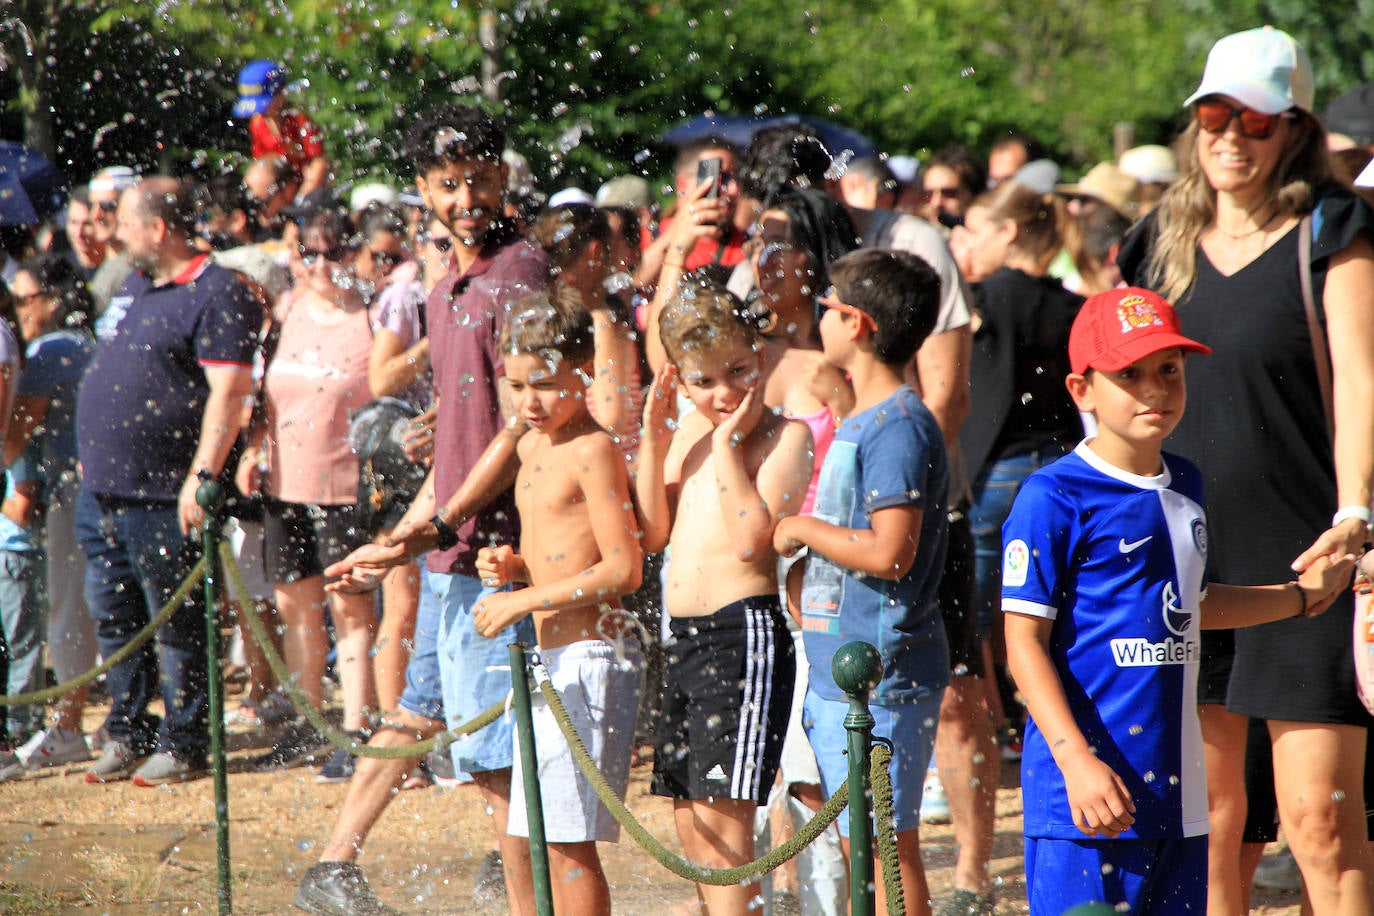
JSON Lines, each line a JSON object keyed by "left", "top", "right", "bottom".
{"left": 830, "top": 643, "right": 882, "bottom": 916}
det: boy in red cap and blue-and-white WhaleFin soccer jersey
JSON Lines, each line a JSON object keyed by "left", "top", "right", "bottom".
{"left": 1002, "top": 287, "right": 1355, "bottom": 916}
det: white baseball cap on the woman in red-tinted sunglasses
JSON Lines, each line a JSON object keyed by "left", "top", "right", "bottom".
{"left": 1183, "top": 26, "right": 1314, "bottom": 114}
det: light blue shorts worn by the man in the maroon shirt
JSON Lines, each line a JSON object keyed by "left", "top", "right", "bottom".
{"left": 429, "top": 573, "right": 534, "bottom": 773}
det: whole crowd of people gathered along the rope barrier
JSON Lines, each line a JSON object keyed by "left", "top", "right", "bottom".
{"left": 0, "top": 29, "right": 1374, "bottom": 916}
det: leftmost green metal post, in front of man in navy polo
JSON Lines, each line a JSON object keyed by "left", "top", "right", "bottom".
{"left": 195, "top": 471, "right": 230, "bottom": 913}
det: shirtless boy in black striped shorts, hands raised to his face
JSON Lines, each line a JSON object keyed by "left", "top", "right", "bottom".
{"left": 636, "top": 284, "right": 812, "bottom": 916}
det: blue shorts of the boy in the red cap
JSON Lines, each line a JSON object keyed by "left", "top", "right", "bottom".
{"left": 1025, "top": 836, "right": 1206, "bottom": 916}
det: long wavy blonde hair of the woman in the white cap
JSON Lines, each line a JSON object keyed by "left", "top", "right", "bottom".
{"left": 1146, "top": 108, "right": 1331, "bottom": 302}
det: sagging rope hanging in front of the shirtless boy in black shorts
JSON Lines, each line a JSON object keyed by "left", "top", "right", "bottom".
{"left": 539, "top": 661, "right": 857, "bottom": 886}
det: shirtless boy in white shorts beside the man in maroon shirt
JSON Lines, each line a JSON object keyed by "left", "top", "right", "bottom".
{"left": 473, "top": 298, "right": 643, "bottom": 915}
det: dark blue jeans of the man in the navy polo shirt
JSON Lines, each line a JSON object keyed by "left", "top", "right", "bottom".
{"left": 77, "top": 490, "right": 209, "bottom": 765}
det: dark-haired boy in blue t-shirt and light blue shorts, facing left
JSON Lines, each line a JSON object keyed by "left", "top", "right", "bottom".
{"left": 774, "top": 249, "right": 949, "bottom": 912}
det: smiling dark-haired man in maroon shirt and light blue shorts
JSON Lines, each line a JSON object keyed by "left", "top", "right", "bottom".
{"left": 297, "top": 106, "right": 548, "bottom": 912}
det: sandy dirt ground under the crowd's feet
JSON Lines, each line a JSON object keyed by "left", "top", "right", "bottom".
{"left": 0, "top": 696, "right": 1298, "bottom": 916}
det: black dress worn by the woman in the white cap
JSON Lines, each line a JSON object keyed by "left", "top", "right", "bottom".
{"left": 1121, "top": 188, "right": 1374, "bottom": 726}
